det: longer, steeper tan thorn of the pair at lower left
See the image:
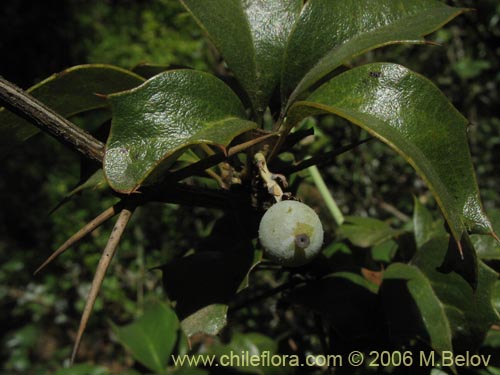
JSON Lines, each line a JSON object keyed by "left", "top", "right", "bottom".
{"left": 70, "top": 208, "right": 134, "bottom": 365}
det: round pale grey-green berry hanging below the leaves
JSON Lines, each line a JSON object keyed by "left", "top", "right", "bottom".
{"left": 259, "top": 201, "right": 323, "bottom": 267}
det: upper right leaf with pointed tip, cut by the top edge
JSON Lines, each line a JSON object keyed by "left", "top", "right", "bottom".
{"left": 281, "top": 0, "right": 464, "bottom": 107}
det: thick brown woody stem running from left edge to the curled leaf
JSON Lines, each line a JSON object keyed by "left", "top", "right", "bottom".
{"left": 0, "top": 76, "right": 104, "bottom": 163}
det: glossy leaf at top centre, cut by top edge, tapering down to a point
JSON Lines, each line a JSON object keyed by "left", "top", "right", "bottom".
{"left": 182, "top": 0, "right": 302, "bottom": 116}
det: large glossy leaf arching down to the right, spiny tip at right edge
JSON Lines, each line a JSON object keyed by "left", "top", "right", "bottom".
{"left": 289, "top": 63, "right": 492, "bottom": 251}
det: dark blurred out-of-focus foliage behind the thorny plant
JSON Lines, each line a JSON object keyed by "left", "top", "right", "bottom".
{"left": 0, "top": 0, "right": 500, "bottom": 374}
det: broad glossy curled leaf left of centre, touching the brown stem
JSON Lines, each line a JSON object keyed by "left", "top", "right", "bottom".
{"left": 104, "top": 70, "right": 257, "bottom": 193}
